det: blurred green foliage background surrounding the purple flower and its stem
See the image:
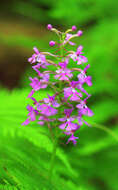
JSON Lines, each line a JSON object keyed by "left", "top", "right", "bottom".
{"left": 0, "top": 0, "right": 118, "bottom": 190}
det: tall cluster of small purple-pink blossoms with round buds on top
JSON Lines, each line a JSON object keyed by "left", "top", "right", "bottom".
{"left": 22, "top": 24, "right": 93, "bottom": 144}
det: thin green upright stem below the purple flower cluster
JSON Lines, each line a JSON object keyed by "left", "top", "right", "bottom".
{"left": 49, "top": 138, "right": 58, "bottom": 180}
